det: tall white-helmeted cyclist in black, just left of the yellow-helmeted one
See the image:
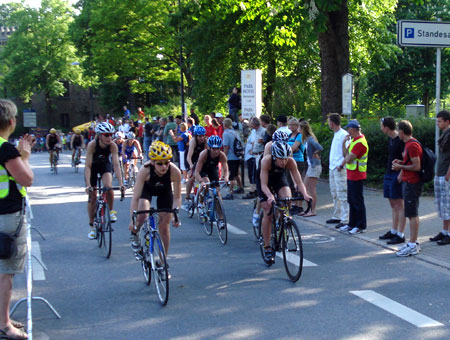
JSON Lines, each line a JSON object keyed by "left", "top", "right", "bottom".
{"left": 84, "top": 122, "right": 125, "bottom": 240}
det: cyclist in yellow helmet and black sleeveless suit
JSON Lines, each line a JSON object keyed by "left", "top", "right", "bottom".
{"left": 128, "top": 141, "right": 181, "bottom": 266}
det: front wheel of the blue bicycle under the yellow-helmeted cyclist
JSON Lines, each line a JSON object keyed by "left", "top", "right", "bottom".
{"left": 151, "top": 233, "right": 169, "bottom": 306}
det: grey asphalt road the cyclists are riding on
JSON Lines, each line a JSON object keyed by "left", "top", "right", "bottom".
{"left": 9, "top": 153, "right": 450, "bottom": 340}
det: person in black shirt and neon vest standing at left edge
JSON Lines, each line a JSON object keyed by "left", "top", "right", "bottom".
{"left": 0, "top": 100, "right": 34, "bottom": 339}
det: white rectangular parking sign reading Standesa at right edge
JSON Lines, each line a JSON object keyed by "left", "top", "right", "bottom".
{"left": 397, "top": 20, "right": 450, "bottom": 47}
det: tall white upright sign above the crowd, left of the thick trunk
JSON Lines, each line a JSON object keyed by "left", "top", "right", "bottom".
{"left": 241, "top": 70, "right": 262, "bottom": 119}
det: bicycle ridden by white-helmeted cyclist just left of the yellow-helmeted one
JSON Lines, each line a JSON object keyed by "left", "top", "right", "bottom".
{"left": 91, "top": 176, "right": 125, "bottom": 259}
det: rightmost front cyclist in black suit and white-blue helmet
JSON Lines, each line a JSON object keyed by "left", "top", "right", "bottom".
{"left": 257, "top": 142, "right": 311, "bottom": 263}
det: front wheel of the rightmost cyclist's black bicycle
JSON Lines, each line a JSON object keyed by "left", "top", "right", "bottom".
{"left": 281, "top": 220, "right": 303, "bottom": 282}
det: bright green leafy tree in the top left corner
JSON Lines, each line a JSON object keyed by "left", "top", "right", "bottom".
{"left": 0, "top": 0, "right": 85, "bottom": 124}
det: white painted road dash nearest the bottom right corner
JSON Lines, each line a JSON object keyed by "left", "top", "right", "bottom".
{"left": 350, "top": 290, "right": 443, "bottom": 328}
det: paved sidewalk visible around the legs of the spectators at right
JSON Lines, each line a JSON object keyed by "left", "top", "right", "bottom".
{"left": 288, "top": 180, "right": 450, "bottom": 270}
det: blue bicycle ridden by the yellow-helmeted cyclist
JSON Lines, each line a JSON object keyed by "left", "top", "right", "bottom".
{"left": 133, "top": 208, "right": 178, "bottom": 306}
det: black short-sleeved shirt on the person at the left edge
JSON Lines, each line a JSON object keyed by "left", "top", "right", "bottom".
{"left": 0, "top": 142, "right": 22, "bottom": 215}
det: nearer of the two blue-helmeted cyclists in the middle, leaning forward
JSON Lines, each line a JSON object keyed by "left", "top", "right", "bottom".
{"left": 194, "top": 135, "right": 228, "bottom": 210}
